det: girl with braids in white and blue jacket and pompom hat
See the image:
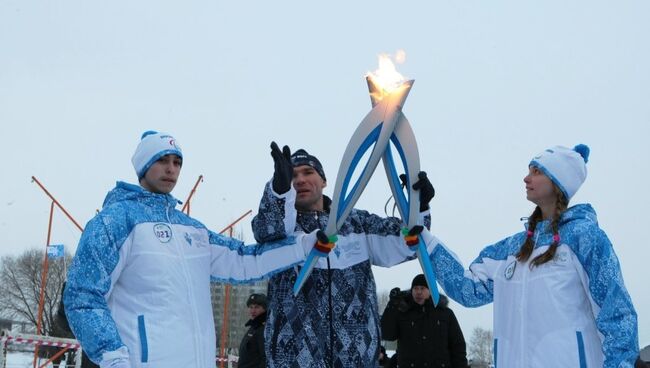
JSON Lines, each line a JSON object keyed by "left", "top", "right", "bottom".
{"left": 423, "top": 145, "right": 639, "bottom": 368}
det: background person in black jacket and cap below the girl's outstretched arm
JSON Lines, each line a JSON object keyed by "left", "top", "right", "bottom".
{"left": 381, "top": 274, "right": 467, "bottom": 368}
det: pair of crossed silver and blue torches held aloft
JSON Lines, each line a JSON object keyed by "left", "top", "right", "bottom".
{"left": 293, "top": 59, "right": 440, "bottom": 305}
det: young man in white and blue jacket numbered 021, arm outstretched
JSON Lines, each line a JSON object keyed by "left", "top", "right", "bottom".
{"left": 64, "top": 132, "right": 316, "bottom": 368}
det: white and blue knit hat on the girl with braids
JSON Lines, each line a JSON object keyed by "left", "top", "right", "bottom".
{"left": 528, "top": 144, "right": 589, "bottom": 201}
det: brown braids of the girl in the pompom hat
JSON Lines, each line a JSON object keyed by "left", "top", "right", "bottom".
{"left": 517, "top": 185, "right": 569, "bottom": 268}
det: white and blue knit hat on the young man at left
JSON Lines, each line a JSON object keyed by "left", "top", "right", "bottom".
{"left": 131, "top": 130, "right": 183, "bottom": 179}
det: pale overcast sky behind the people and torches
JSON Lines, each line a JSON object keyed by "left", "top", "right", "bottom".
{"left": 0, "top": 0, "right": 650, "bottom": 347}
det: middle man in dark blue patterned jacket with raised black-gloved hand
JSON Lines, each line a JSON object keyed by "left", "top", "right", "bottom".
{"left": 253, "top": 142, "right": 433, "bottom": 368}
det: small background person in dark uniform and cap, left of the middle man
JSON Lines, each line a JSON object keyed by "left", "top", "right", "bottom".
{"left": 238, "top": 294, "right": 267, "bottom": 368}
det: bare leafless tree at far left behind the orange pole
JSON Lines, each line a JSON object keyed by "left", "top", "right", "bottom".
{"left": 0, "top": 249, "right": 72, "bottom": 335}
